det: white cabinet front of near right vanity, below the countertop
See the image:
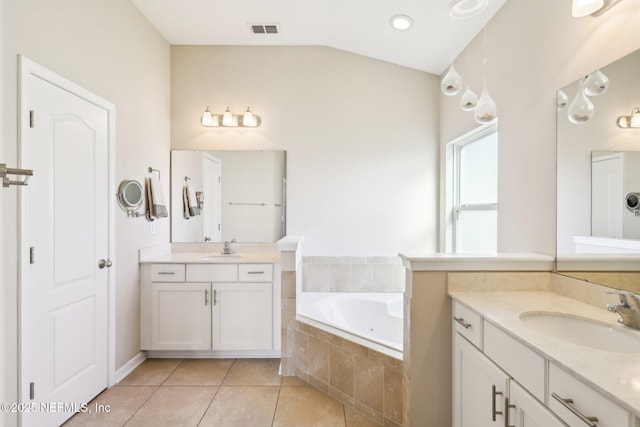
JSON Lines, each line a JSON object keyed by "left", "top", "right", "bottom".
{"left": 453, "top": 300, "right": 636, "bottom": 427}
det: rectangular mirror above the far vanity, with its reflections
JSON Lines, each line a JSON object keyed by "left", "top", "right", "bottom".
{"left": 171, "top": 150, "right": 286, "bottom": 243}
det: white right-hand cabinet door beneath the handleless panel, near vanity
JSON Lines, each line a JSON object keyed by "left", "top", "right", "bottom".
{"left": 507, "top": 381, "right": 567, "bottom": 427}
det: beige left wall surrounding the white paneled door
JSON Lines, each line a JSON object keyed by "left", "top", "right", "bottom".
{"left": 0, "top": 0, "right": 170, "bottom": 425}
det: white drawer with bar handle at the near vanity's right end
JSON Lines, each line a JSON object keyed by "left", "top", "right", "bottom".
{"left": 549, "top": 363, "right": 630, "bottom": 427}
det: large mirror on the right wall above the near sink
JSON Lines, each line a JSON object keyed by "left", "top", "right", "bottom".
{"left": 556, "top": 51, "right": 640, "bottom": 292}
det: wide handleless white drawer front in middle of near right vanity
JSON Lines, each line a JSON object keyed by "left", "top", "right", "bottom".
{"left": 483, "top": 320, "right": 545, "bottom": 402}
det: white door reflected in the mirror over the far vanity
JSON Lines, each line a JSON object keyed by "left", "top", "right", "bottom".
{"left": 202, "top": 154, "right": 222, "bottom": 242}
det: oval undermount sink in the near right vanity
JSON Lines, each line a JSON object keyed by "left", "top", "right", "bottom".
{"left": 520, "top": 311, "right": 640, "bottom": 353}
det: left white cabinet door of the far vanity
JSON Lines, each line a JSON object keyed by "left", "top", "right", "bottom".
{"left": 149, "top": 283, "right": 212, "bottom": 350}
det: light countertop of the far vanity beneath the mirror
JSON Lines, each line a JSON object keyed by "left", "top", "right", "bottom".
{"left": 140, "top": 252, "right": 280, "bottom": 264}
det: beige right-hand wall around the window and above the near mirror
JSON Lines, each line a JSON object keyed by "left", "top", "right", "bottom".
{"left": 440, "top": 0, "right": 640, "bottom": 255}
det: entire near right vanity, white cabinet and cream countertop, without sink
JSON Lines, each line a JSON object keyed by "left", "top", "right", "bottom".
{"left": 452, "top": 292, "right": 640, "bottom": 427}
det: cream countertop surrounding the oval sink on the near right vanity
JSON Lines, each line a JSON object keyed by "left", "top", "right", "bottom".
{"left": 449, "top": 291, "right": 640, "bottom": 416}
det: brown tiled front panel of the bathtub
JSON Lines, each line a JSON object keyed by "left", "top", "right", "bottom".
{"left": 295, "top": 322, "right": 403, "bottom": 426}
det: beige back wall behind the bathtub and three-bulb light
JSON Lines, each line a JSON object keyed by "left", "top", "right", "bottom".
{"left": 171, "top": 46, "right": 439, "bottom": 256}
